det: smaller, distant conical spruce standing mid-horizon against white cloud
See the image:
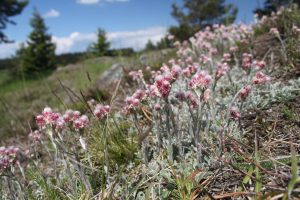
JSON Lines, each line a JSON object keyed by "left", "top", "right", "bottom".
{"left": 88, "top": 28, "right": 110, "bottom": 57}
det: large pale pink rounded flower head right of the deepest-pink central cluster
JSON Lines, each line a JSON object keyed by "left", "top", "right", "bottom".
{"left": 189, "top": 71, "right": 212, "bottom": 89}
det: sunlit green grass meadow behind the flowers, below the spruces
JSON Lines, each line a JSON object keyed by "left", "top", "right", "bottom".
{"left": 0, "top": 51, "right": 174, "bottom": 139}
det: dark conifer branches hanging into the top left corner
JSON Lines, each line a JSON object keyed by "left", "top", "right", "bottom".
{"left": 0, "top": 0, "right": 28, "bottom": 43}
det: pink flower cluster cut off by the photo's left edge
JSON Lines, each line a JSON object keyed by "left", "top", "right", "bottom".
{"left": 0, "top": 146, "right": 20, "bottom": 173}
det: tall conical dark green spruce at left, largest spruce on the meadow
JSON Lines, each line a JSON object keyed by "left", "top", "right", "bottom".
{"left": 19, "top": 11, "right": 56, "bottom": 75}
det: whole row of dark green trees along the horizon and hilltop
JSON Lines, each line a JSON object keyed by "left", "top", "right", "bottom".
{"left": 0, "top": 0, "right": 300, "bottom": 76}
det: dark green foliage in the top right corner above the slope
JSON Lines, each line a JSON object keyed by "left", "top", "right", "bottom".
{"left": 254, "top": 0, "right": 300, "bottom": 18}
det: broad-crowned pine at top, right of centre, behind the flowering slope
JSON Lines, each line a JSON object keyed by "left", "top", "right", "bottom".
{"left": 171, "top": 0, "right": 238, "bottom": 40}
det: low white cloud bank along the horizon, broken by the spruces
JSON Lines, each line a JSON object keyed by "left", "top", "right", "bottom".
{"left": 0, "top": 27, "right": 167, "bottom": 58}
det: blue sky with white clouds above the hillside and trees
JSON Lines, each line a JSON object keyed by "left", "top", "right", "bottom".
{"left": 0, "top": 0, "right": 263, "bottom": 58}
